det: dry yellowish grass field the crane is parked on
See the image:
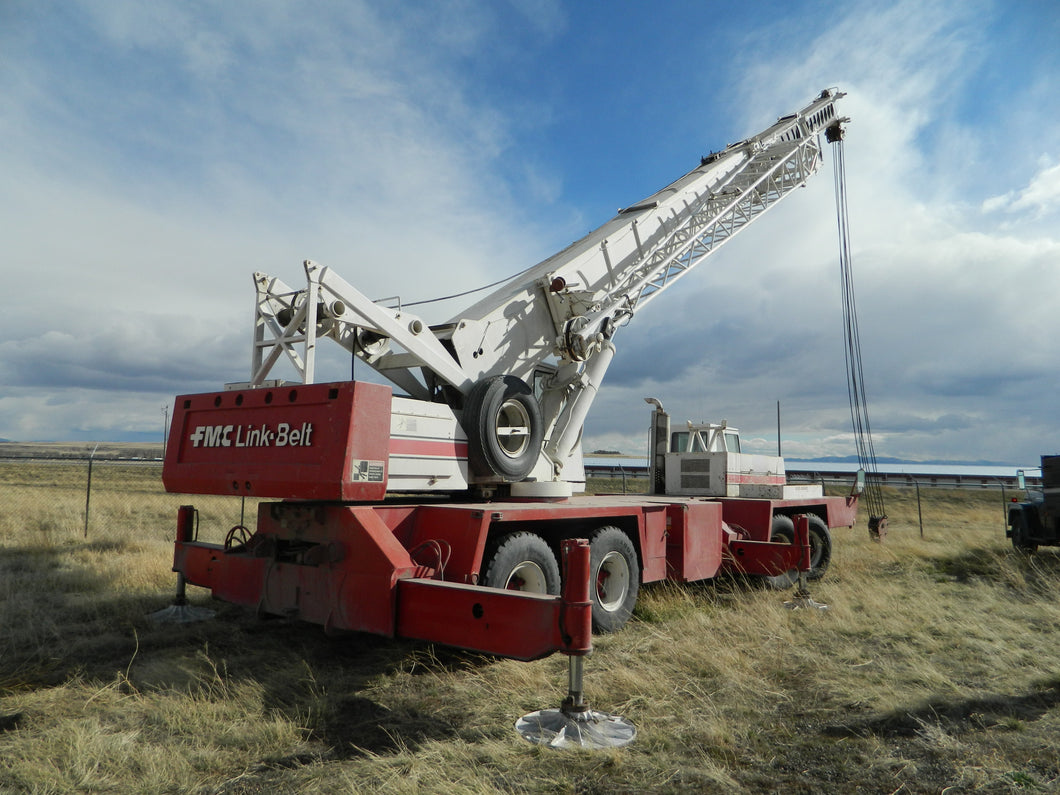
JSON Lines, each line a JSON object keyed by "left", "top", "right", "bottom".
{"left": 0, "top": 464, "right": 1060, "bottom": 793}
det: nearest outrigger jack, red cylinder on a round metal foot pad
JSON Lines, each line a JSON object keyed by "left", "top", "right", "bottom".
{"left": 515, "top": 538, "right": 637, "bottom": 748}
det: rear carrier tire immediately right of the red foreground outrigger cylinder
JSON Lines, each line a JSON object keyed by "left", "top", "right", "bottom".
{"left": 589, "top": 526, "right": 640, "bottom": 634}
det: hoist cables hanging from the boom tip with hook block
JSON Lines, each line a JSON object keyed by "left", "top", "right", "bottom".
{"left": 825, "top": 122, "right": 887, "bottom": 541}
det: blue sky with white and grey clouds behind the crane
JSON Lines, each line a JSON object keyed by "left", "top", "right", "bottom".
{"left": 0, "top": 0, "right": 1060, "bottom": 464}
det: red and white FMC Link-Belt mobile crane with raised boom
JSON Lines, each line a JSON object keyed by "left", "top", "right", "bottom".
{"left": 163, "top": 90, "right": 856, "bottom": 659}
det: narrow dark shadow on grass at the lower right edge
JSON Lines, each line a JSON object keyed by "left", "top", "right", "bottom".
{"left": 823, "top": 681, "right": 1060, "bottom": 738}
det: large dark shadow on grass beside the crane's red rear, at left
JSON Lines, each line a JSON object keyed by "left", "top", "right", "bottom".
{"left": 0, "top": 541, "right": 493, "bottom": 758}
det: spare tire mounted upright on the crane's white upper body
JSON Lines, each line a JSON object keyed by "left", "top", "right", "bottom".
{"left": 463, "top": 375, "right": 545, "bottom": 483}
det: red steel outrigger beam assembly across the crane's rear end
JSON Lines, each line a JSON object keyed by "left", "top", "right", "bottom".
{"left": 174, "top": 525, "right": 591, "bottom": 660}
